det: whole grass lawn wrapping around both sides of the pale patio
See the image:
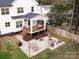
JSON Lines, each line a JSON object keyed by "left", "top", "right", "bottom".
{"left": 0, "top": 34, "right": 79, "bottom": 59}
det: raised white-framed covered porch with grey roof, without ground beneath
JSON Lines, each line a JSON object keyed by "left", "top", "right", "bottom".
{"left": 25, "top": 13, "right": 48, "bottom": 34}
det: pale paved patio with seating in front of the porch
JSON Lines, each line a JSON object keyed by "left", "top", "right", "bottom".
{"left": 16, "top": 35, "right": 65, "bottom": 57}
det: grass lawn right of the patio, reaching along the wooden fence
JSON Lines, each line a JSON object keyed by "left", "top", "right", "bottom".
{"left": 30, "top": 34, "right": 79, "bottom": 59}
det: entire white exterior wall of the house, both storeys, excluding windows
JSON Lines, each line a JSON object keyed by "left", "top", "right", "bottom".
{"left": 0, "top": 0, "right": 39, "bottom": 35}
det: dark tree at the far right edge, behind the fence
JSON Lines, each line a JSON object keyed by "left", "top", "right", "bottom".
{"left": 73, "top": 0, "right": 79, "bottom": 34}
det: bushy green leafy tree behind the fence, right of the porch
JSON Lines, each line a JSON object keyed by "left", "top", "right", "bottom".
{"left": 48, "top": 4, "right": 69, "bottom": 26}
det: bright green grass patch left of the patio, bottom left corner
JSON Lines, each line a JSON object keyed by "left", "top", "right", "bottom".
{"left": 0, "top": 43, "right": 28, "bottom": 59}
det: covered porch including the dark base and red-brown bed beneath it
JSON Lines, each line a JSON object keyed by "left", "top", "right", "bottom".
{"left": 24, "top": 13, "right": 48, "bottom": 41}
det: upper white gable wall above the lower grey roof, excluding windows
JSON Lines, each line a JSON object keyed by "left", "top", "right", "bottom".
{"left": 10, "top": 0, "right": 39, "bottom": 16}
